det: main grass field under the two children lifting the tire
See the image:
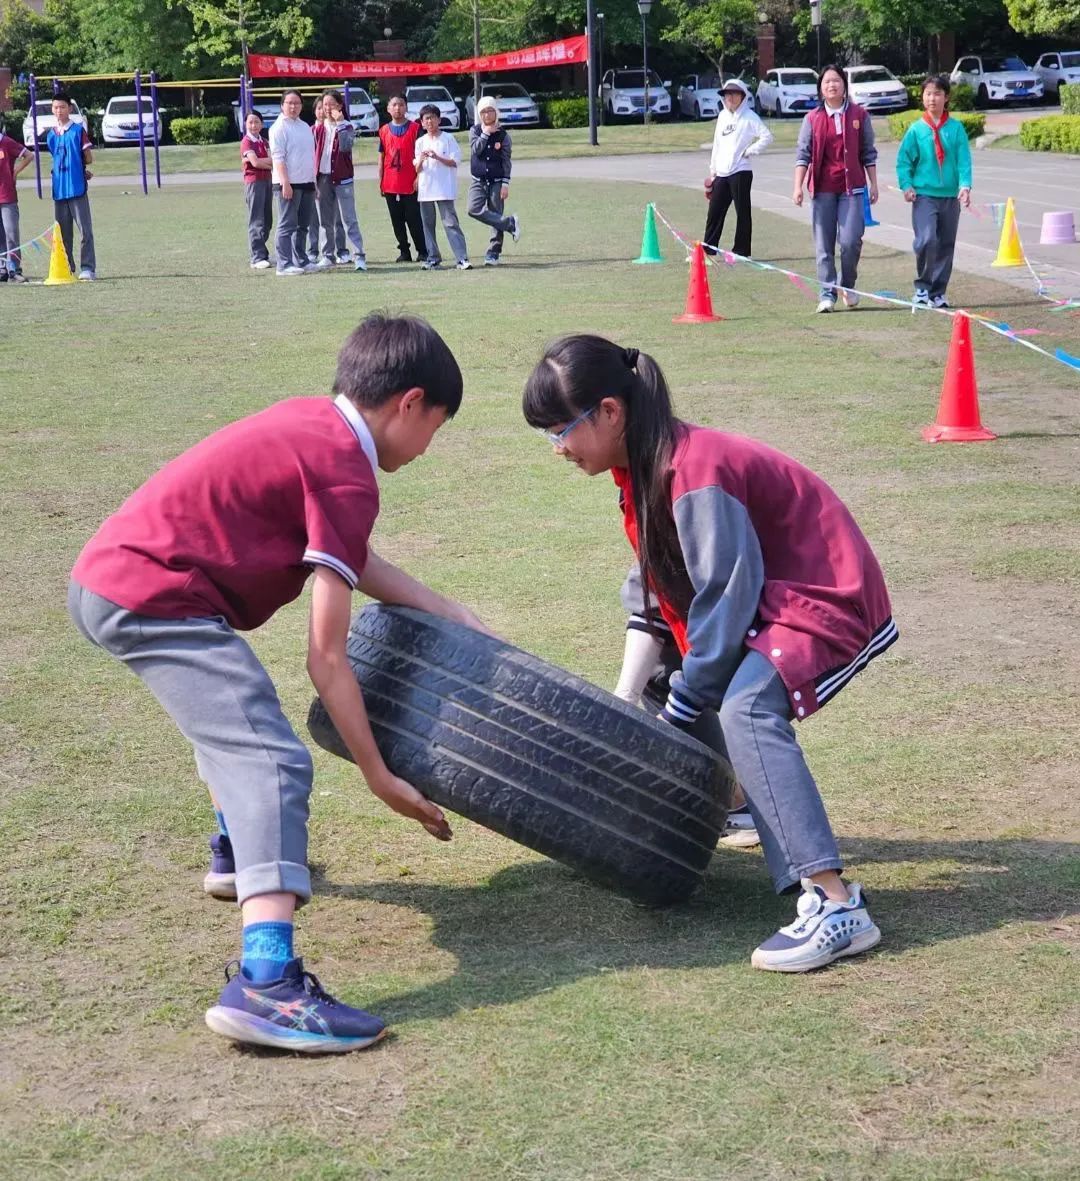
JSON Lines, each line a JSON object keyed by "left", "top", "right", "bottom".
{"left": 0, "top": 181, "right": 1080, "bottom": 1181}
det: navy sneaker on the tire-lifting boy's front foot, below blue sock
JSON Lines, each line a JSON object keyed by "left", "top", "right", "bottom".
{"left": 207, "top": 959, "right": 386, "bottom": 1053}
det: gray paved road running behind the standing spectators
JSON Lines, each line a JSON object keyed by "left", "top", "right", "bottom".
{"left": 86, "top": 139, "right": 1080, "bottom": 295}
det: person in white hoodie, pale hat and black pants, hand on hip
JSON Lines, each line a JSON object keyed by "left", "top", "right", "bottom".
{"left": 703, "top": 78, "right": 773, "bottom": 259}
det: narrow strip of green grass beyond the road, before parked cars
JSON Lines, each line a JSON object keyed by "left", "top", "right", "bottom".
{"left": 83, "top": 119, "right": 808, "bottom": 175}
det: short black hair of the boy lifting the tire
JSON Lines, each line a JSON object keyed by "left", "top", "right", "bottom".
{"left": 333, "top": 312, "right": 462, "bottom": 418}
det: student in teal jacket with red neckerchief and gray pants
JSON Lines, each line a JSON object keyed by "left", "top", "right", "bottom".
{"left": 896, "top": 74, "right": 971, "bottom": 307}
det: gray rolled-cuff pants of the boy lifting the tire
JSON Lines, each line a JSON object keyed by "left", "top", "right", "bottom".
{"left": 67, "top": 582, "right": 313, "bottom": 902}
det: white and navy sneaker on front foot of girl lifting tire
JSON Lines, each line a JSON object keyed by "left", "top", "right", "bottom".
{"left": 750, "top": 877, "right": 881, "bottom": 972}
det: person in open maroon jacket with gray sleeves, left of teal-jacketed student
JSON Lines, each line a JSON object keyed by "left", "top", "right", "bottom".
{"left": 792, "top": 66, "right": 878, "bottom": 312}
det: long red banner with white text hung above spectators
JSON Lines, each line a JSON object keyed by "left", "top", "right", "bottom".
{"left": 248, "top": 35, "right": 588, "bottom": 79}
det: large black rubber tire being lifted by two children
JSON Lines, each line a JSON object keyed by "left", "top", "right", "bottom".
{"left": 307, "top": 605, "right": 734, "bottom": 905}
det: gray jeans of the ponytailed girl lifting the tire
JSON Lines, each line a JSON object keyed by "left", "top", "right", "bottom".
{"left": 643, "top": 645, "right": 842, "bottom": 894}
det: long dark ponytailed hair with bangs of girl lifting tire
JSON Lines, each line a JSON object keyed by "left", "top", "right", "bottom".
{"left": 521, "top": 333, "right": 691, "bottom": 611}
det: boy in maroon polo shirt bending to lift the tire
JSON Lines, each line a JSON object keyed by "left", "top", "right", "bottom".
{"left": 69, "top": 314, "right": 482, "bottom": 1053}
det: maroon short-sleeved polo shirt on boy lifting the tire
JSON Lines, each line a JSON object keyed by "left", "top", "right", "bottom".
{"left": 72, "top": 398, "right": 379, "bottom": 631}
